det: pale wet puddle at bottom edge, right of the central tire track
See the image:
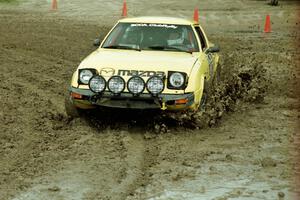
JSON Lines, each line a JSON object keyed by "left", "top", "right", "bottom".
{"left": 148, "top": 180, "right": 292, "bottom": 200}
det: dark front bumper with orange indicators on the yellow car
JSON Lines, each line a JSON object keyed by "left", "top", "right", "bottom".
{"left": 69, "top": 87, "right": 194, "bottom": 110}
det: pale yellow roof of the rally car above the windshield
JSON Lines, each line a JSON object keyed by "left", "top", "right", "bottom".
{"left": 119, "top": 17, "right": 197, "bottom": 25}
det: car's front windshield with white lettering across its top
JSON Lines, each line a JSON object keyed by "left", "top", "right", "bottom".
{"left": 102, "top": 23, "right": 199, "bottom": 53}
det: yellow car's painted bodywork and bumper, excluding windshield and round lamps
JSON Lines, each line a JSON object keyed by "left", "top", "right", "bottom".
{"left": 70, "top": 17, "right": 219, "bottom": 110}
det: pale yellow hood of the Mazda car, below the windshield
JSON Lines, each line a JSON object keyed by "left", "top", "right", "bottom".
{"left": 79, "top": 49, "right": 198, "bottom": 76}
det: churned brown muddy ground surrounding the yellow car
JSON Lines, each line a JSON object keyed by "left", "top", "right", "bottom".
{"left": 0, "top": 0, "right": 300, "bottom": 200}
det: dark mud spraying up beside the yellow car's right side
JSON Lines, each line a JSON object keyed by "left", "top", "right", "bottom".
{"left": 155, "top": 55, "right": 270, "bottom": 132}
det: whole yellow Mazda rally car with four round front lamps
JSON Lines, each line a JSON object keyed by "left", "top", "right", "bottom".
{"left": 66, "top": 17, "right": 221, "bottom": 117}
